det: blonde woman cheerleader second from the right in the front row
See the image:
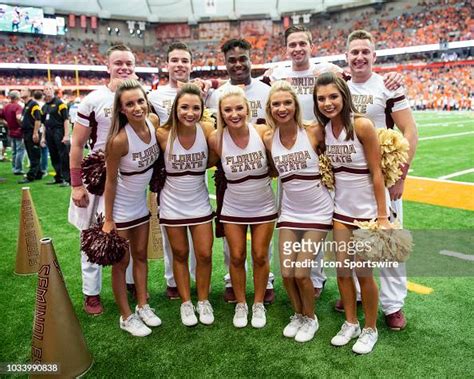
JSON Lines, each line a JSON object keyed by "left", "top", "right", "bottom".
{"left": 264, "top": 80, "right": 334, "bottom": 342}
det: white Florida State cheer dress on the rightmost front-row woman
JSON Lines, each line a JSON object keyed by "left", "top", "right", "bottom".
{"left": 326, "top": 121, "right": 377, "bottom": 225}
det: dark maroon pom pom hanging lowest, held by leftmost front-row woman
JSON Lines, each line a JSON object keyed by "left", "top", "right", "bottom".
{"left": 81, "top": 215, "right": 129, "bottom": 266}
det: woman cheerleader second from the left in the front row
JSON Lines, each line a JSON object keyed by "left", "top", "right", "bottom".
{"left": 157, "top": 84, "right": 216, "bottom": 326}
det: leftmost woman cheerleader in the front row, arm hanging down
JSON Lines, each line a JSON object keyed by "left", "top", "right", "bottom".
{"left": 103, "top": 79, "right": 161, "bottom": 337}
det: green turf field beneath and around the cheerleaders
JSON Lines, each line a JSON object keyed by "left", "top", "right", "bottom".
{"left": 0, "top": 112, "right": 474, "bottom": 378}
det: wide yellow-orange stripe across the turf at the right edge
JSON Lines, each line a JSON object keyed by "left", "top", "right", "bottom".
{"left": 403, "top": 176, "right": 474, "bottom": 211}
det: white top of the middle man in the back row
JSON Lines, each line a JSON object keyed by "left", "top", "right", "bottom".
{"left": 206, "top": 79, "right": 271, "bottom": 123}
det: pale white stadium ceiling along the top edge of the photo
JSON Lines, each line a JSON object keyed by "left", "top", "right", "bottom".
{"left": 0, "top": 0, "right": 372, "bottom": 22}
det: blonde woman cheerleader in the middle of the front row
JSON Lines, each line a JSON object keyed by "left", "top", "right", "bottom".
{"left": 209, "top": 86, "right": 277, "bottom": 328}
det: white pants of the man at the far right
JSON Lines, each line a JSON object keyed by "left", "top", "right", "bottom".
{"left": 354, "top": 199, "right": 407, "bottom": 315}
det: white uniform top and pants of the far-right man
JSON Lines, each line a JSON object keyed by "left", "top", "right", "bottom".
{"left": 347, "top": 73, "right": 410, "bottom": 315}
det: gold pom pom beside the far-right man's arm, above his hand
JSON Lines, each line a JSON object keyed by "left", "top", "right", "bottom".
{"left": 377, "top": 129, "right": 410, "bottom": 188}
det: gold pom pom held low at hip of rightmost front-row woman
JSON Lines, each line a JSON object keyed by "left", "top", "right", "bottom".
{"left": 354, "top": 219, "right": 413, "bottom": 262}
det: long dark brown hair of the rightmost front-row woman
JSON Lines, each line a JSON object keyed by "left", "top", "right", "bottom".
{"left": 313, "top": 72, "right": 357, "bottom": 140}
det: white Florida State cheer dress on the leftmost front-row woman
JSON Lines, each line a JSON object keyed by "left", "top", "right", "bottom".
{"left": 113, "top": 122, "right": 160, "bottom": 230}
